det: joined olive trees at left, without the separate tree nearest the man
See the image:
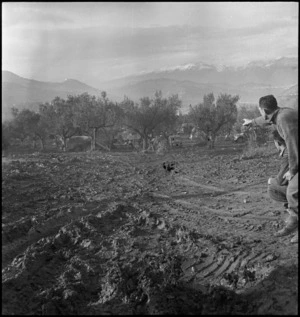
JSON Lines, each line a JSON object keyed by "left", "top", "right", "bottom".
{"left": 2, "top": 92, "right": 181, "bottom": 150}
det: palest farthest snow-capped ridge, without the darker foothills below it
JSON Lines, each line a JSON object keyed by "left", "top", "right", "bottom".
{"left": 102, "top": 57, "right": 298, "bottom": 86}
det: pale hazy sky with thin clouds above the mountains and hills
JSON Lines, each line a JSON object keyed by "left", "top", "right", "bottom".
{"left": 2, "top": 2, "right": 299, "bottom": 88}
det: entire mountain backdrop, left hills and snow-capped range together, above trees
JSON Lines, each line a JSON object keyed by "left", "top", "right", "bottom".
{"left": 2, "top": 57, "right": 298, "bottom": 121}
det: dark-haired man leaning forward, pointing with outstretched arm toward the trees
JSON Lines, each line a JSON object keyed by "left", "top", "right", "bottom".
{"left": 243, "top": 95, "right": 298, "bottom": 243}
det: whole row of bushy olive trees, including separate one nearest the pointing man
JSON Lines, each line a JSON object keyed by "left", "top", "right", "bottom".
{"left": 2, "top": 91, "right": 248, "bottom": 150}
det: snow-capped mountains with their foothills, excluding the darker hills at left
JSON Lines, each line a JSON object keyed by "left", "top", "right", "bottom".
{"left": 101, "top": 57, "right": 298, "bottom": 109}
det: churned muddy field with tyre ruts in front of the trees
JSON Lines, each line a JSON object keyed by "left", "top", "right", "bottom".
{"left": 2, "top": 144, "right": 298, "bottom": 315}
